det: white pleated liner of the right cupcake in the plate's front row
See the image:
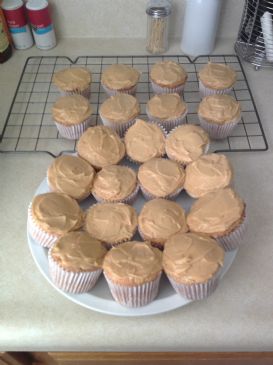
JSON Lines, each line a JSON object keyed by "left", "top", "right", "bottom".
{"left": 167, "top": 275, "right": 219, "bottom": 300}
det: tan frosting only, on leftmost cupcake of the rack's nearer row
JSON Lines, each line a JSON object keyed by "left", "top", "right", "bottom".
{"left": 52, "top": 95, "right": 92, "bottom": 125}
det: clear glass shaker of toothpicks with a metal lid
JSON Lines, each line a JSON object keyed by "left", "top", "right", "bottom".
{"left": 146, "top": 0, "right": 172, "bottom": 54}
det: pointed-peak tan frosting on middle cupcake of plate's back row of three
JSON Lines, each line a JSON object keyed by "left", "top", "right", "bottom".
{"left": 124, "top": 119, "right": 165, "bottom": 163}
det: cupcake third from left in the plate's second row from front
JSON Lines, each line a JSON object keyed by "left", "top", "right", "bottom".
{"left": 138, "top": 199, "right": 188, "bottom": 249}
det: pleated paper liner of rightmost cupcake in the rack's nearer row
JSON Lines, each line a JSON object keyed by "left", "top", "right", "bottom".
{"left": 198, "top": 115, "right": 241, "bottom": 139}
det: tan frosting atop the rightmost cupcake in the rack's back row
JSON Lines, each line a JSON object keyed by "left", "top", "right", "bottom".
{"left": 198, "top": 63, "right": 236, "bottom": 90}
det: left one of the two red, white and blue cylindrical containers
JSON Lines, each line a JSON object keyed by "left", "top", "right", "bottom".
{"left": 2, "top": 0, "right": 33, "bottom": 49}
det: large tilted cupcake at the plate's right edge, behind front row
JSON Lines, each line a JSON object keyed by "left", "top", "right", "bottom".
{"left": 187, "top": 188, "right": 246, "bottom": 251}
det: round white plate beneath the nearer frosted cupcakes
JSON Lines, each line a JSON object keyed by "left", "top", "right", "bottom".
{"left": 27, "top": 165, "right": 237, "bottom": 317}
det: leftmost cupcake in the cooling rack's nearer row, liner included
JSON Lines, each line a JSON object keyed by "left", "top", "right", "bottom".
{"left": 52, "top": 95, "right": 92, "bottom": 139}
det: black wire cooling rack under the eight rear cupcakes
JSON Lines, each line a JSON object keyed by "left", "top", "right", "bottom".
{"left": 0, "top": 55, "right": 268, "bottom": 156}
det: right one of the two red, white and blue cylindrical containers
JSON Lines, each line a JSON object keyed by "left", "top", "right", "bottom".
{"left": 26, "top": 0, "right": 56, "bottom": 50}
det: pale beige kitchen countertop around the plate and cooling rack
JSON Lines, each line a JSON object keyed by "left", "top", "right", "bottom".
{"left": 0, "top": 39, "right": 273, "bottom": 351}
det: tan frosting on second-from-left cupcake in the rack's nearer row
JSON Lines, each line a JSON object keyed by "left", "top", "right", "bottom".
{"left": 99, "top": 94, "right": 140, "bottom": 124}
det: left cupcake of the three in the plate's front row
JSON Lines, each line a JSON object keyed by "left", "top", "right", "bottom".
{"left": 48, "top": 232, "right": 107, "bottom": 294}
